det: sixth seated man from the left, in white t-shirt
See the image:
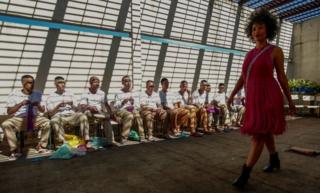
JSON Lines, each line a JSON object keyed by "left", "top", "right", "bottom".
{"left": 159, "top": 78, "right": 189, "bottom": 138}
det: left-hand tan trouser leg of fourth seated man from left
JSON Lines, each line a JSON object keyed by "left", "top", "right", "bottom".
{"left": 115, "top": 109, "right": 134, "bottom": 139}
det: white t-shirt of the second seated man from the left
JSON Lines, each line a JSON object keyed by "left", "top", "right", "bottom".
{"left": 47, "top": 91, "right": 78, "bottom": 115}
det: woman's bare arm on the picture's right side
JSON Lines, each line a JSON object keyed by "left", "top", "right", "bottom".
{"left": 272, "top": 47, "right": 295, "bottom": 113}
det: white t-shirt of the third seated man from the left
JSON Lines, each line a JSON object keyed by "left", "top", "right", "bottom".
{"left": 79, "top": 89, "right": 108, "bottom": 112}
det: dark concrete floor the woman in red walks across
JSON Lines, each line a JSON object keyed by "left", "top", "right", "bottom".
{"left": 0, "top": 118, "right": 320, "bottom": 193}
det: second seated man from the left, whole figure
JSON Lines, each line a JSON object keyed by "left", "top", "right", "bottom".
{"left": 47, "top": 76, "right": 90, "bottom": 147}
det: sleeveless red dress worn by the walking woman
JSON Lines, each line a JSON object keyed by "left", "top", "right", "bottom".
{"left": 240, "top": 45, "right": 286, "bottom": 135}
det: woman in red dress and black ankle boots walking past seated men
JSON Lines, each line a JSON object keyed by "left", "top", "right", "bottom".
{"left": 227, "top": 9, "right": 295, "bottom": 187}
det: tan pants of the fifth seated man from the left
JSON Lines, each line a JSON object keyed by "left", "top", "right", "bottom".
{"left": 141, "top": 109, "right": 168, "bottom": 138}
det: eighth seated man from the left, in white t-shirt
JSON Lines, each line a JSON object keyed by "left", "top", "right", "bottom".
{"left": 192, "top": 80, "right": 212, "bottom": 135}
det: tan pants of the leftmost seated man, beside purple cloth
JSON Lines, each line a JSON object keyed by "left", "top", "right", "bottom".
{"left": 1, "top": 115, "right": 50, "bottom": 151}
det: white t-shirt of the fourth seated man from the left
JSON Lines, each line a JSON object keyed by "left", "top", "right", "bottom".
{"left": 114, "top": 89, "right": 140, "bottom": 110}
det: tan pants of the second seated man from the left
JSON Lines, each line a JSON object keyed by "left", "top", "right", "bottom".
{"left": 50, "top": 112, "right": 90, "bottom": 142}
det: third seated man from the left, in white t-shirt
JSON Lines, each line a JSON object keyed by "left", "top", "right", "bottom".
{"left": 80, "top": 76, "right": 114, "bottom": 145}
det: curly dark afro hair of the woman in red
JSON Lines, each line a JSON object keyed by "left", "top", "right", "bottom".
{"left": 245, "top": 8, "right": 279, "bottom": 41}
